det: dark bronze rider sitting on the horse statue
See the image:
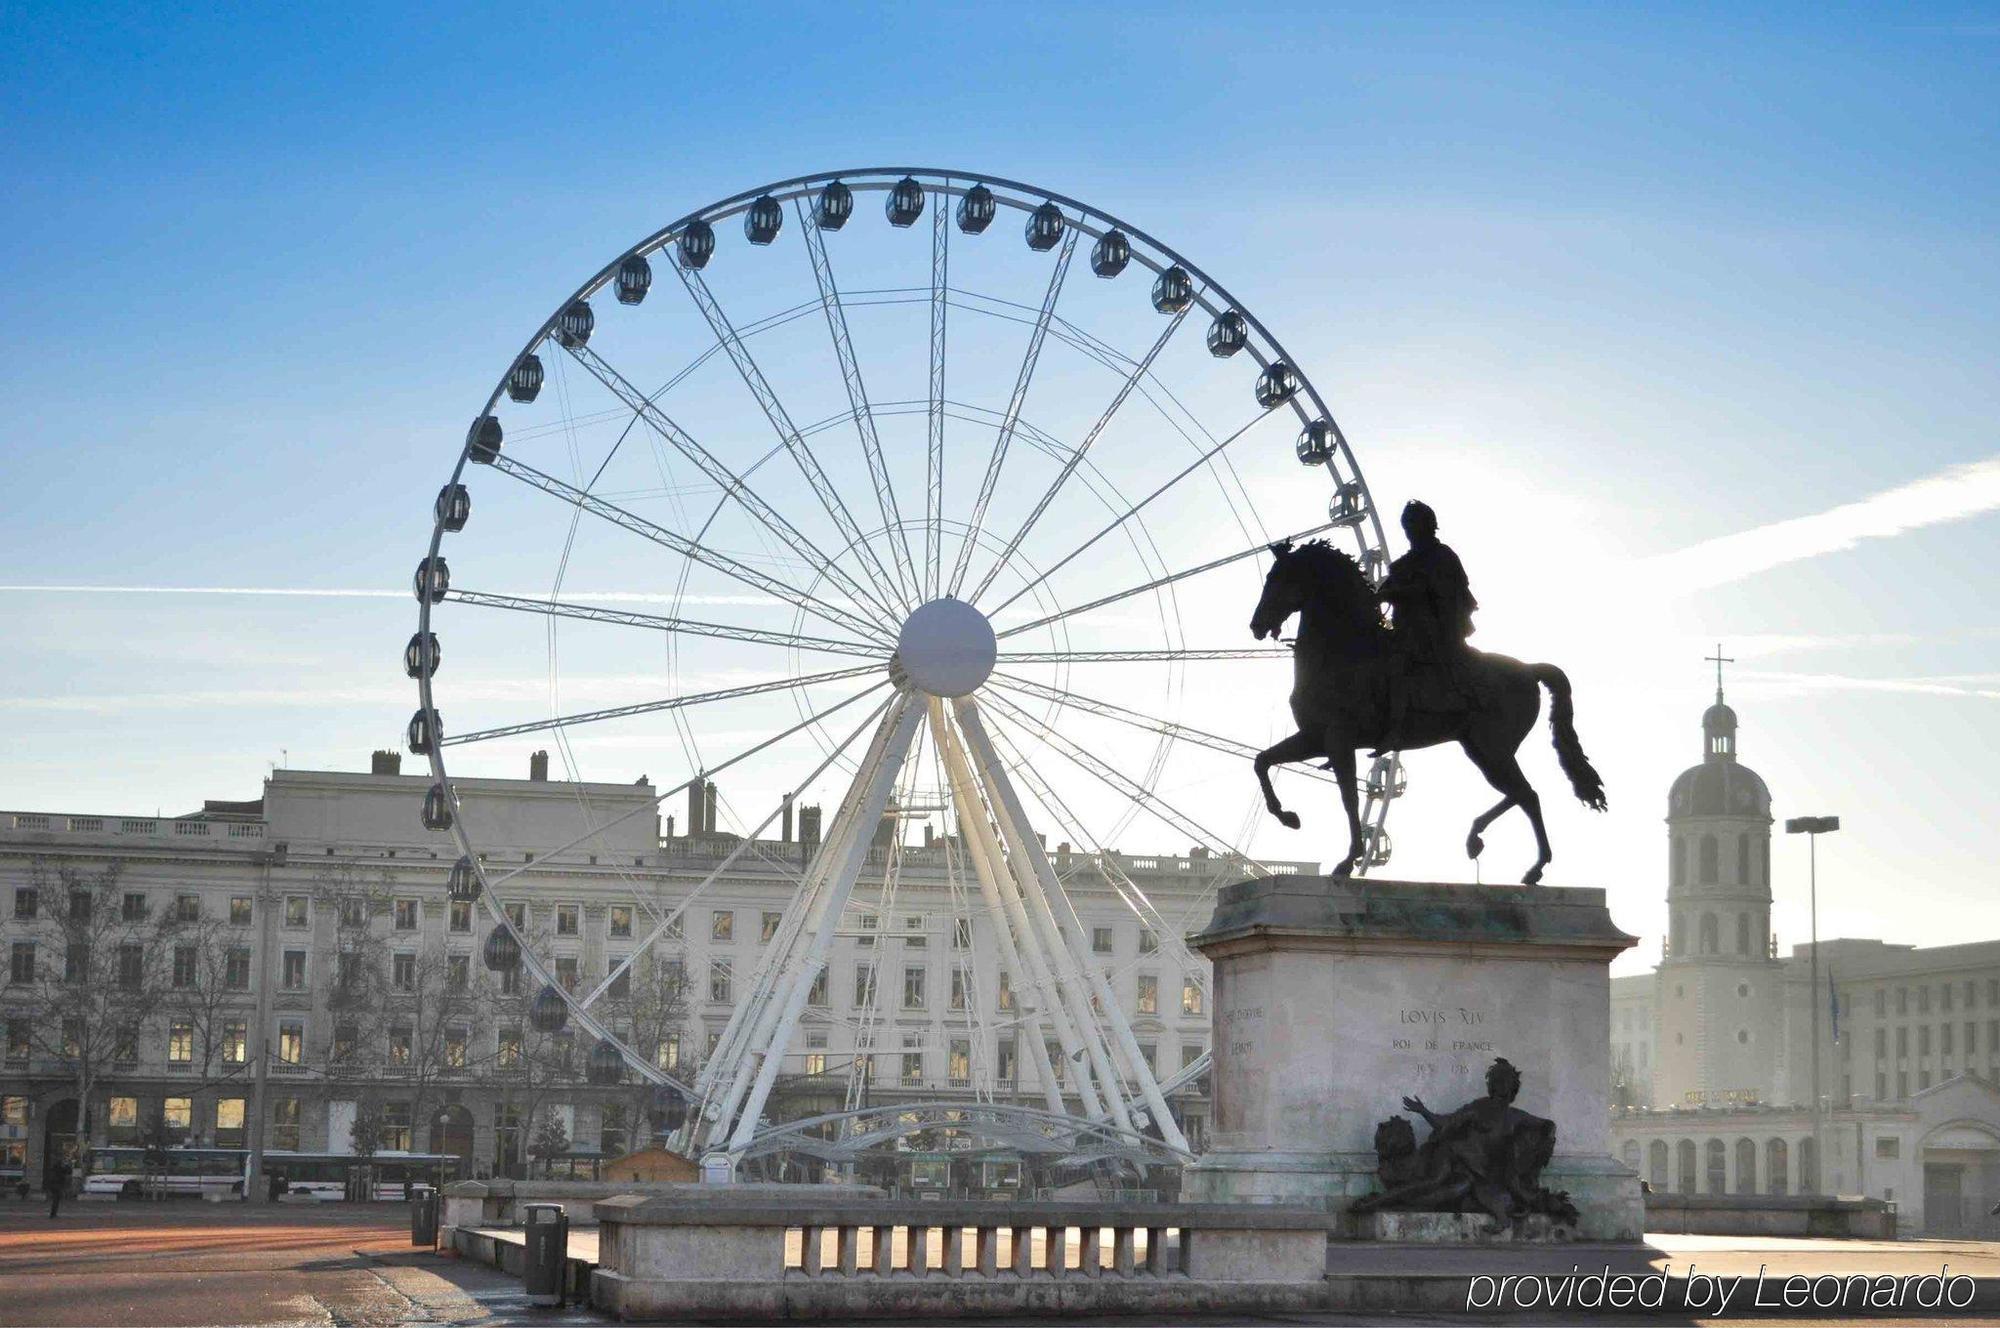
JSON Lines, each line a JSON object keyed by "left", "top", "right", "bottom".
{"left": 1376, "top": 500, "right": 1480, "bottom": 748}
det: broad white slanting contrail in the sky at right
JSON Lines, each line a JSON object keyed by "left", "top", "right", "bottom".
{"left": 1642, "top": 456, "right": 2000, "bottom": 592}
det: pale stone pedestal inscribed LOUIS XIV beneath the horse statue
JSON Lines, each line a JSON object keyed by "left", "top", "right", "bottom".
{"left": 1182, "top": 876, "right": 1644, "bottom": 1240}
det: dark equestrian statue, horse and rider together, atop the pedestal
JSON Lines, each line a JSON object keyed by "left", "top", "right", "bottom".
{"left": 1250, "top": 502, "right": 1606, "bottom": 886}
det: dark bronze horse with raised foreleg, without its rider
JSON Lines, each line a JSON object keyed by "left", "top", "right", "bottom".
{"left": 1250, "top": 540, "right": 1604, "bottom": 886}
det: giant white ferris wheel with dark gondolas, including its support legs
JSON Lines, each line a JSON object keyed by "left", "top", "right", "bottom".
{"left": 404, "top": 168, "right": 1400, "bottom": 1156}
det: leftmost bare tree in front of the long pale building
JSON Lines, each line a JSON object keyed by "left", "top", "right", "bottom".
{"left": 12, "top": 860, "right": 182, "bottom": 1146}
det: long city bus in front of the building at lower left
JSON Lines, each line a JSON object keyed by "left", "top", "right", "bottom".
{"left": 82, "top": 1144, "right": 458, "bottom": 1202}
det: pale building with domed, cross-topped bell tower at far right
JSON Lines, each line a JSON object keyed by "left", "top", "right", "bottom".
{"left": 1612, "top": 682, "right": 2000, "bottom": 1238}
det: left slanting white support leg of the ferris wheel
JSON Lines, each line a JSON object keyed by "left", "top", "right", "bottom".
{"left": 718, "top": 692, "right": 924, "bottom": 1154}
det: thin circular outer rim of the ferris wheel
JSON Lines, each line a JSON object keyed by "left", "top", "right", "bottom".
{"left": 418, "top": 166, "right": 1386, "bottom": 1094}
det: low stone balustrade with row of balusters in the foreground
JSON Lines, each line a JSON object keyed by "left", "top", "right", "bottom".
{"left": 592, "top": 1186, "right": 1330, "bottom": 1320}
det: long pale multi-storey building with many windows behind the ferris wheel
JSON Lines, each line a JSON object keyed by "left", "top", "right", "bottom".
{"left": 0, "top": 754, "right": 1264, "bottom": 1190}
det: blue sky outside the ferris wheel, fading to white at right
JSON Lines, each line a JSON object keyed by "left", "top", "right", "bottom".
{"left": 0, "top": 4, "right": 2000, "bottom": 976}
